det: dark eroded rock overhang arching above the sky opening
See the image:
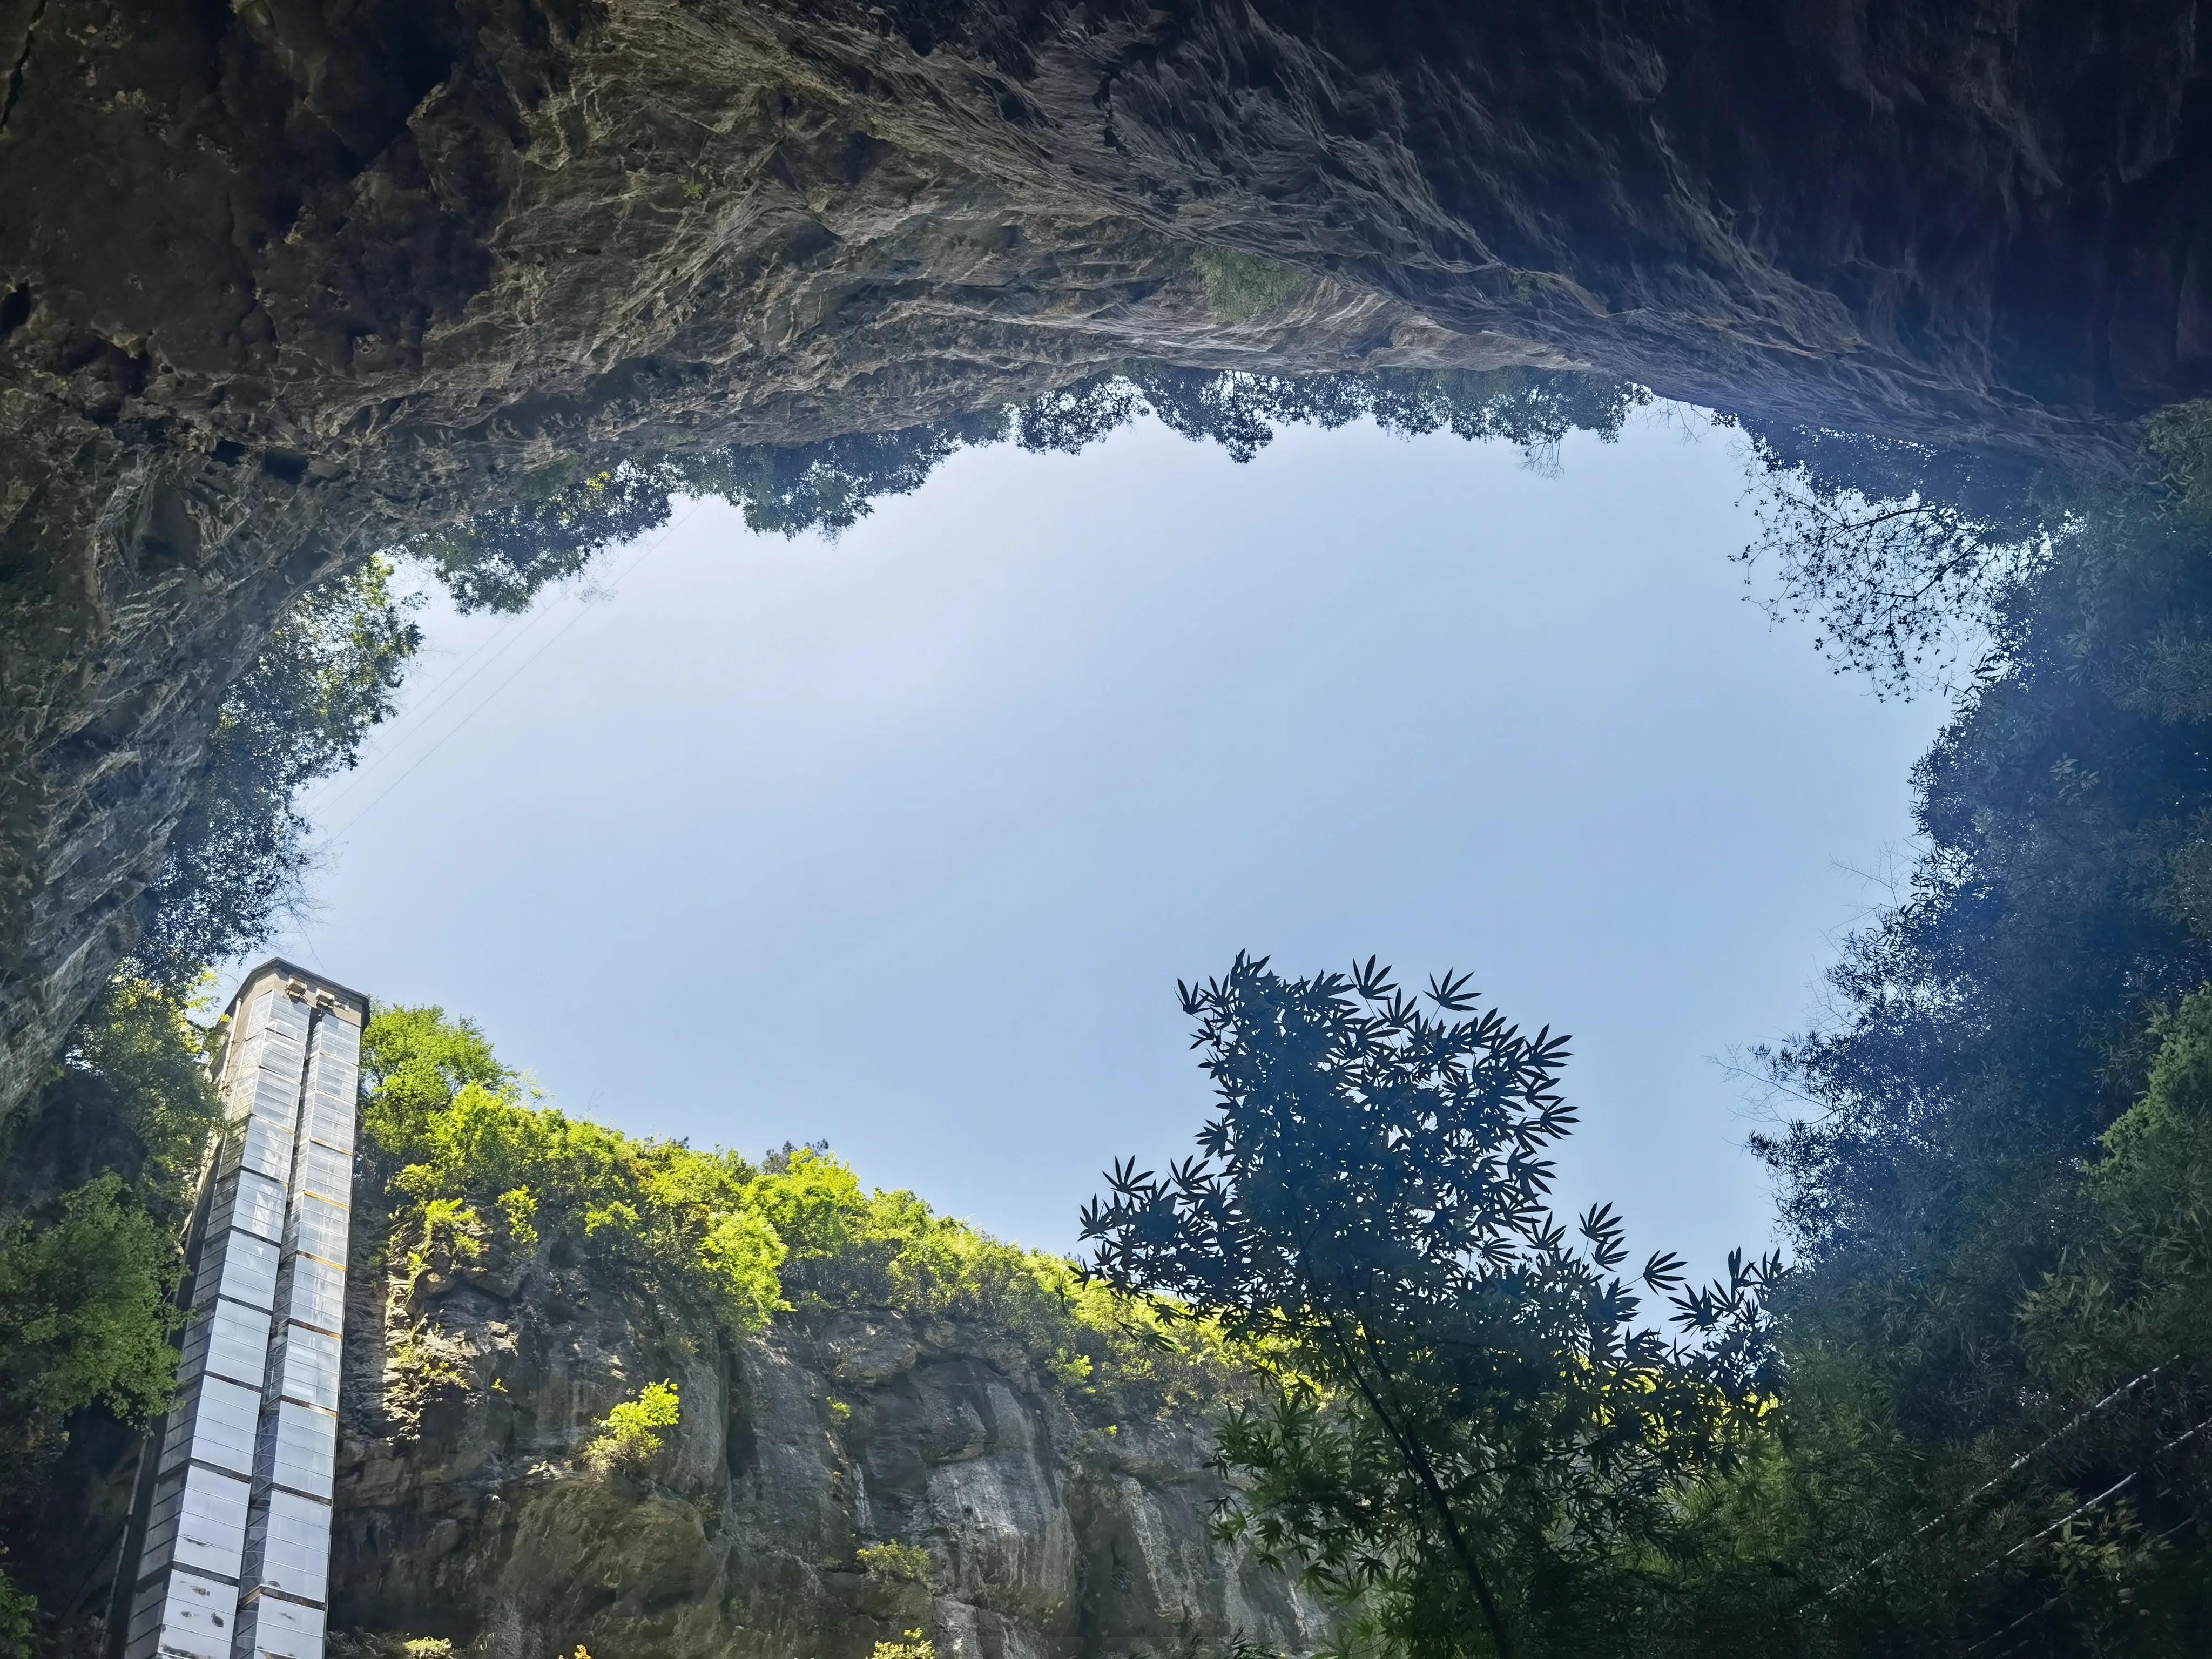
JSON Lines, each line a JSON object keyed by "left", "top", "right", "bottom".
{"left": 0, "top": 0, "right": 2212, "bottom": 1106}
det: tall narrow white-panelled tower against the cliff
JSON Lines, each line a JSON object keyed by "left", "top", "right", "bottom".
{"left": 124, "top": 962, "right": 369, "bottom": 1659}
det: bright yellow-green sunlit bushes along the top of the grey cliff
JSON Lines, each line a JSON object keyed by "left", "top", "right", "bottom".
{"left": 361, "top": 1009, "right": 1237, "bottom": 1413}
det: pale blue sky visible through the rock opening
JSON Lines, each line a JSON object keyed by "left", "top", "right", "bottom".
{"left": 263, "top": 414, "right": 1942, "bottom": 1270}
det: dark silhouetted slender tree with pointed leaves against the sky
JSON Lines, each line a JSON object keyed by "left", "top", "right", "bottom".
{"left": 1082, "top": 955, "right": 1778, "bottom": 1659}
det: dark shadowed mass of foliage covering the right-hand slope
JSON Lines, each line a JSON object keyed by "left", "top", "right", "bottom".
{"left": 1675, "top": 407, "right": 2212, "bottom": 1655}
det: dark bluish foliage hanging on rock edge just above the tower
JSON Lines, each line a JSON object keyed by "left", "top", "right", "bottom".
{"left": 135, "top": 559, "right": 422, "bottom": 987}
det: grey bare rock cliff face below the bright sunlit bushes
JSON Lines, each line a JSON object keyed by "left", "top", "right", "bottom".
{"left": 332, "top": 1223, "right": 1327, "bottom": 1659}
